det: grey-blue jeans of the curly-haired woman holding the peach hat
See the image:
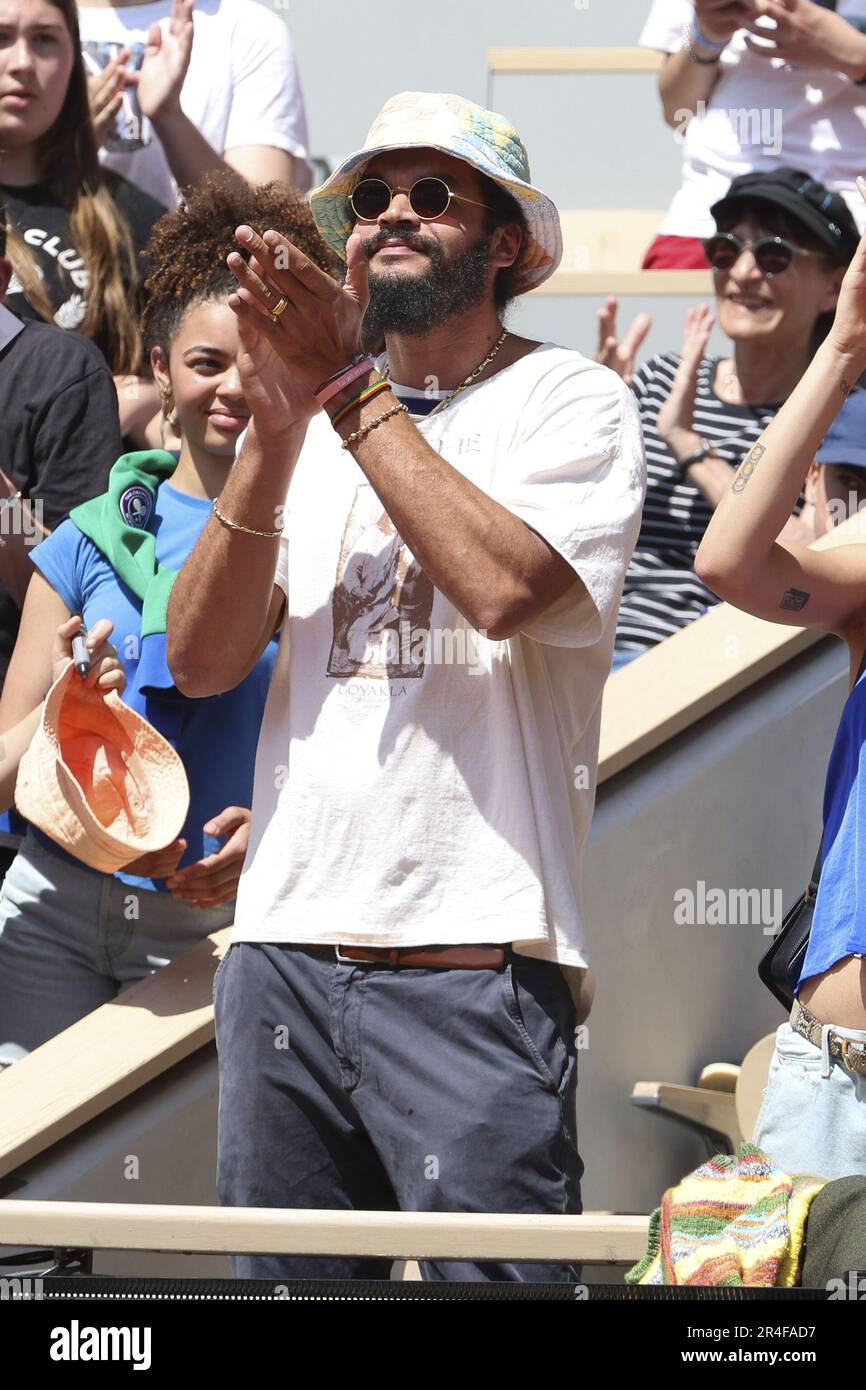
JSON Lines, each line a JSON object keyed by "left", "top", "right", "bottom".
{"left": 0, "top": 831, "right": 235, "bottom": 1065}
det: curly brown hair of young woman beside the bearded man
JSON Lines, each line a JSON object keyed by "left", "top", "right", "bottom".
{"left": 142, "top": 171, "right": 343, "bottom": 353}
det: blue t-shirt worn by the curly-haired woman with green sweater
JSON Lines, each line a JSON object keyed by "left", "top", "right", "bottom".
{"left": 32, "top": 482, "right": 278, "bottom": 890}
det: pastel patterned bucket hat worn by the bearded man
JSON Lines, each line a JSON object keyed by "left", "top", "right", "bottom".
{"left": 310, "top": 92, "right": 563, "bottom": 295}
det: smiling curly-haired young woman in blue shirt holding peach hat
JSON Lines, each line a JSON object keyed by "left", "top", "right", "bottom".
{"left": 0, "top": 177, "right": 341, "bottom": 1062}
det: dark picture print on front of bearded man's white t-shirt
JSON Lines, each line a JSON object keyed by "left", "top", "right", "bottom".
{"left": 327, "top": 482, "right": 434, "bottom": 680}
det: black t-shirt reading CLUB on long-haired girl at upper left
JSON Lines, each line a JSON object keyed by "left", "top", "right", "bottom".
{"left": 0, "top": 171, "right": 165, "bottom": 353}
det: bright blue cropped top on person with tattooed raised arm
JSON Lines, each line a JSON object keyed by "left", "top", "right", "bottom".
{"left": 799, "top": 673, "right": 866, "bottom": 984}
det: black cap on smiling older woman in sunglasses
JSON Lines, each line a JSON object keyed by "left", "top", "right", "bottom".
{"left": 710, "top": 165, "right": 860, "bottom": 265}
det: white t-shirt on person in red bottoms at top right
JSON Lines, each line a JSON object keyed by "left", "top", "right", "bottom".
{"left": 639, "top": 0, "right": 866, "bottom": 238}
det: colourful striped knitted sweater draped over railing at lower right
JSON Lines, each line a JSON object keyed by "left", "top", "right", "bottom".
{"left": 626, "top": 1144, "right": 827, "bottom": 1289}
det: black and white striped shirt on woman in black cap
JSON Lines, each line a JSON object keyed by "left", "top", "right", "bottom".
{"left": 616, "top": 352, "right": 778, "bottom": 651}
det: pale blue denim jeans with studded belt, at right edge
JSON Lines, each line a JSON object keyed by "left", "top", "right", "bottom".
{"left": 753, "top": 1023, "right": 866, "bottom": 1179}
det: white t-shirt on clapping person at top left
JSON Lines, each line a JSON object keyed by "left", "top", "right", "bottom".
{"left": 78, "top": 0, "right": 309, "bottom": 207}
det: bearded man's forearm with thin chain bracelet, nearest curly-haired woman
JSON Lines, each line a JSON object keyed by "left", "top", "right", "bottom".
{"left": 167, "top": 424, "right": 306, "bottom": 696}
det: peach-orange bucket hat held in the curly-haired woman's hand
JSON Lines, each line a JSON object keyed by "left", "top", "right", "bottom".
{"left": 15, "top": 662, "right": 189, "bottom": 873}
